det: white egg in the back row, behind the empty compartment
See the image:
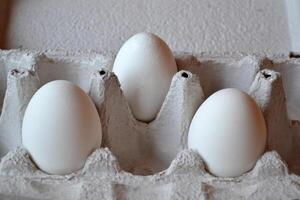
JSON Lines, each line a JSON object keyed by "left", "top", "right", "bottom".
{"left": 113, "top": 33, "right": 177, "bottom": 122}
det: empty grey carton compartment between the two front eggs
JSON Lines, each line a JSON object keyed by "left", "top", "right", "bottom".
{"left": 89, "top": 69, "right": 204, "bottom": 175}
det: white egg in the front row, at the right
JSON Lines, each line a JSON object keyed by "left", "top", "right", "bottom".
{"left": 188, "top": 88, "right": 267, "bottom": 177}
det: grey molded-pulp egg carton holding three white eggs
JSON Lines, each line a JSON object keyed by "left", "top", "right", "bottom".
{"left": 0, "top": 50, "right": 300, "bottom": 200}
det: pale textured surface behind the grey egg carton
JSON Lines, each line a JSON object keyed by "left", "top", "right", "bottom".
{"left": 0, "top": 0, "right": 300, "bottom": 54}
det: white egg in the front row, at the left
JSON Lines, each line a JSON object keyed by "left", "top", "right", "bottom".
{"left": 22, "top": 80, "right": 102, "bottom": 174}
